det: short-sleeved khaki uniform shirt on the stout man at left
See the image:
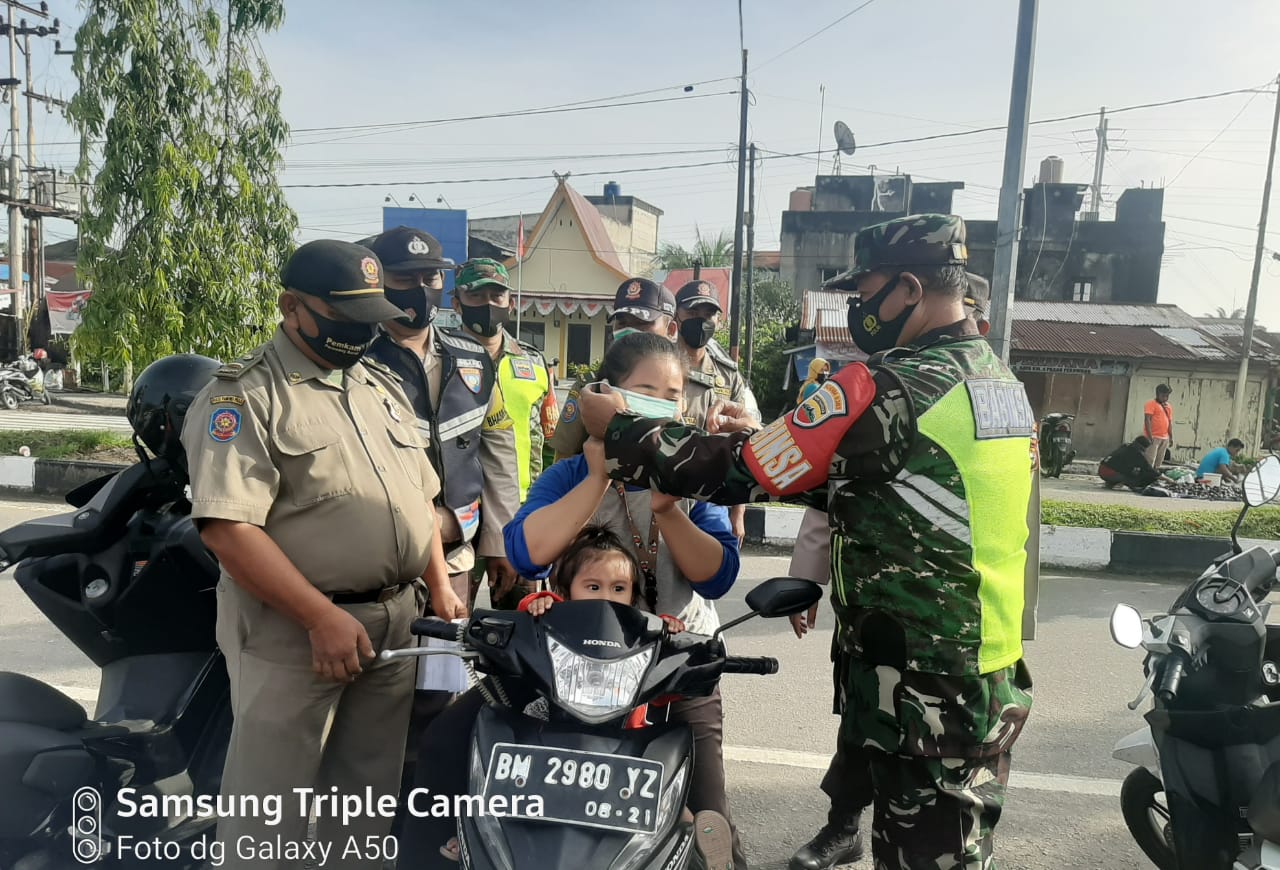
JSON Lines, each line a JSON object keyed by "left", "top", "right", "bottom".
{"left": 182, "top": 330, "right": 440, "bottom": 592}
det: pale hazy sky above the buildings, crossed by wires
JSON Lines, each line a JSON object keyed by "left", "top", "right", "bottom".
{"left": 22, "top": 0, "right": 1280, "bottom": 329}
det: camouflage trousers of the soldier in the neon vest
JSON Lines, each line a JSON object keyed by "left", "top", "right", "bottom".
{"left": 823, "top": 655, "right": 1032, "bottom": 870}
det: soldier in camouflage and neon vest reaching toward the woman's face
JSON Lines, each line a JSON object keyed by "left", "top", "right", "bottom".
{"left": 581, "top": 215, "right": 1034, "bottom": 870}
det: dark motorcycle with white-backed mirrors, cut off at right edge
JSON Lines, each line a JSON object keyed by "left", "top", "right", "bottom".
{"left": 1111, "top": 455, "right": 1280, "bottom": 870}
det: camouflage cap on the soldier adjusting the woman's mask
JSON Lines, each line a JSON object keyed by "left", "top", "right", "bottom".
{"left": 823, "top": 215, "right": 969, "bottom": 290}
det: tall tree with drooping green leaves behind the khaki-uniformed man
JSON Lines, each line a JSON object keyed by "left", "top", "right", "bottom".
{"left": 70, "top": 0, "right": 297, "bottom": 368}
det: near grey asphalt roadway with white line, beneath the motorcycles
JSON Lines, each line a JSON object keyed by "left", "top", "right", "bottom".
{"left": 0, "top": 500, "right": 1178, "bottom": 870}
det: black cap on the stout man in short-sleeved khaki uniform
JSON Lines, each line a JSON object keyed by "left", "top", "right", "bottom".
{"left": 280, "top": 239, "right": 404, "bottom": 324}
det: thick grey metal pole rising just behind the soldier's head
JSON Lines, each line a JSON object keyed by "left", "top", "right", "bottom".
{"left": 987, "top": 0, "right": 1037, "bottom": 362}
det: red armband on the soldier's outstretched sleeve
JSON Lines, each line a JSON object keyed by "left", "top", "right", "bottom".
{"left": 742, "top": 362, "right": 876, "bottom": 495}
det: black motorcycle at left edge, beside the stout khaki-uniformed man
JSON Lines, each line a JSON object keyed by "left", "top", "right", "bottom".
{"left": 0, "top": 459, "right": 230, "bottom": 870}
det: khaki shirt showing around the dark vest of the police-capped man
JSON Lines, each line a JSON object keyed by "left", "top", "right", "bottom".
{"left": 411, "top": 326, "right": 520, "bottom": 574}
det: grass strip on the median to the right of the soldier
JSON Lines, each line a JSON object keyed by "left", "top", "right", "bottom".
{"left": 1041, "top": 500, "right": 1280, "bottom": 539}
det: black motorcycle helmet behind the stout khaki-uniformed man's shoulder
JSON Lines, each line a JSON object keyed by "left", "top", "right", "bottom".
{"left": 124, "top": 353, "right": 223, "bottom": 473}
